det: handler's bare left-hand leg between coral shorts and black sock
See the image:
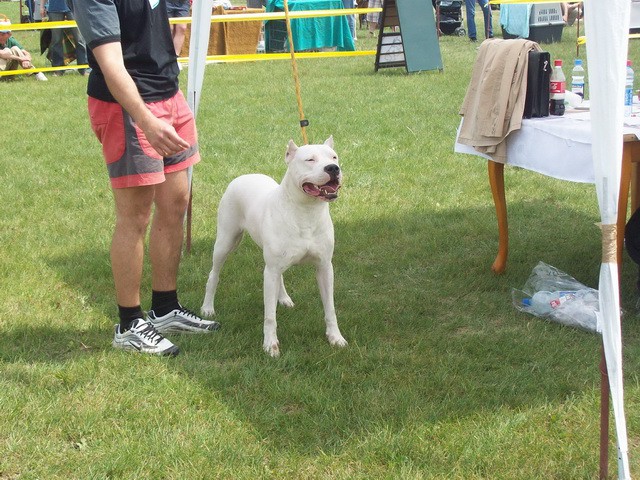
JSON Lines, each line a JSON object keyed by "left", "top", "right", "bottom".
{"left": 111, "top": 186, "right": 154, "bottom": 307}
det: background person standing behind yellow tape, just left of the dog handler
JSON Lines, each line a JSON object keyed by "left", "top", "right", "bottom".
{"left": 40, "top": 0, "right": 88, "bottom": 76}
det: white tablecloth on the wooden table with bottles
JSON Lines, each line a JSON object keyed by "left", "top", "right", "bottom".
{"left": 454, "top": 108, "right": 640, "bottom": 183}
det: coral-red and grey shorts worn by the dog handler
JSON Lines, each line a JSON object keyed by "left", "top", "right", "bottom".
{"left": 89, "top": 91, "right": 200, "bottom": 188}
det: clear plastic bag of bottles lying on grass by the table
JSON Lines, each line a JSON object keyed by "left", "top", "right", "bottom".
{"left": 511, "top": 262, "right": 601, "bottom": 333}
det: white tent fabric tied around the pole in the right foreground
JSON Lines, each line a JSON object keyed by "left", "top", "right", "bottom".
{"left": 584, "top": 0, "right": 631, "bottom": 479}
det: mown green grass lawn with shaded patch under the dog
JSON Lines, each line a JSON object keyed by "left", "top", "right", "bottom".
{"left": 0, "top": 2, "right": 640, "bottom": 480}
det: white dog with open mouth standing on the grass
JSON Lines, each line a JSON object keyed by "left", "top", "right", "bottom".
{"left": 202, "top": 137, "right": 347, "bottom": 357}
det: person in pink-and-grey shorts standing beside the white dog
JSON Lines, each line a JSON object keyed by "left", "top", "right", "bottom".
{"left": 73, "top": 0, "right": 220, "bottom": 355}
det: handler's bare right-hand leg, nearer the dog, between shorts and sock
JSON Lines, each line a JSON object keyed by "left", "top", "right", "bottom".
{"left": 149, "top": 170, "right": 189, "bottom": 291}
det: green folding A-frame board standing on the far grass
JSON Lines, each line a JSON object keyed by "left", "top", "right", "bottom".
{"left": 376, "top": 0, "right": 443, "bottom": 72}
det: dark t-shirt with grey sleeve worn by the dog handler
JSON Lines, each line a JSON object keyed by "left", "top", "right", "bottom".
{"left": 73, "top": 0, "right": 179, "bottom": 103}
